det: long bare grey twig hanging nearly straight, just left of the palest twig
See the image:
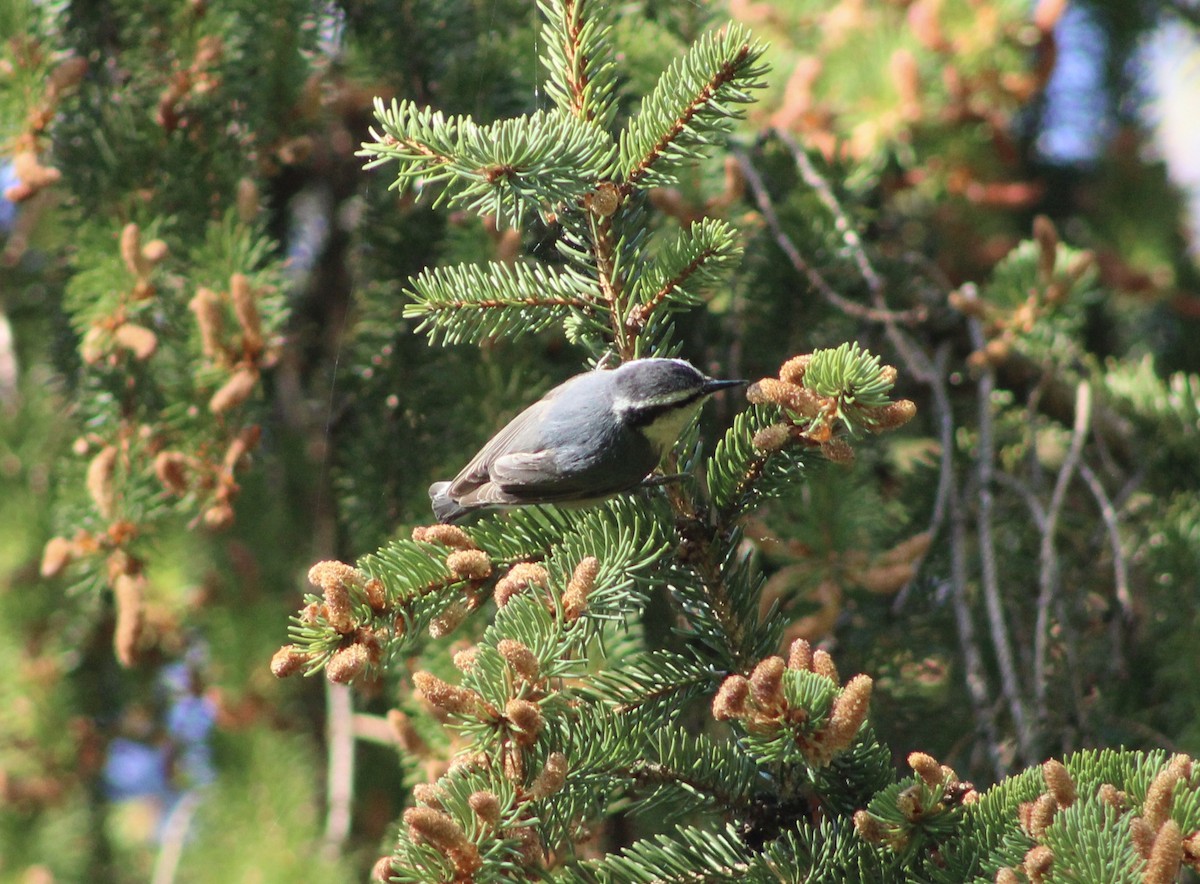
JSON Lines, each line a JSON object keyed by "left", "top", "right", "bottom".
{"left": 964, "top": 302, "right": 1034, "bottom": 764}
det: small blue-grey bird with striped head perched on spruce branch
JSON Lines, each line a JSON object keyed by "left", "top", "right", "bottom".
{"left": 430, "top": 357, "right": 746, "bottom": 523}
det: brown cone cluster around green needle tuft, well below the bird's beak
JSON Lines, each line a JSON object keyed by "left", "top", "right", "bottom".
{"left": 713, "top": 639, "right": 872, "bottom": 766}
